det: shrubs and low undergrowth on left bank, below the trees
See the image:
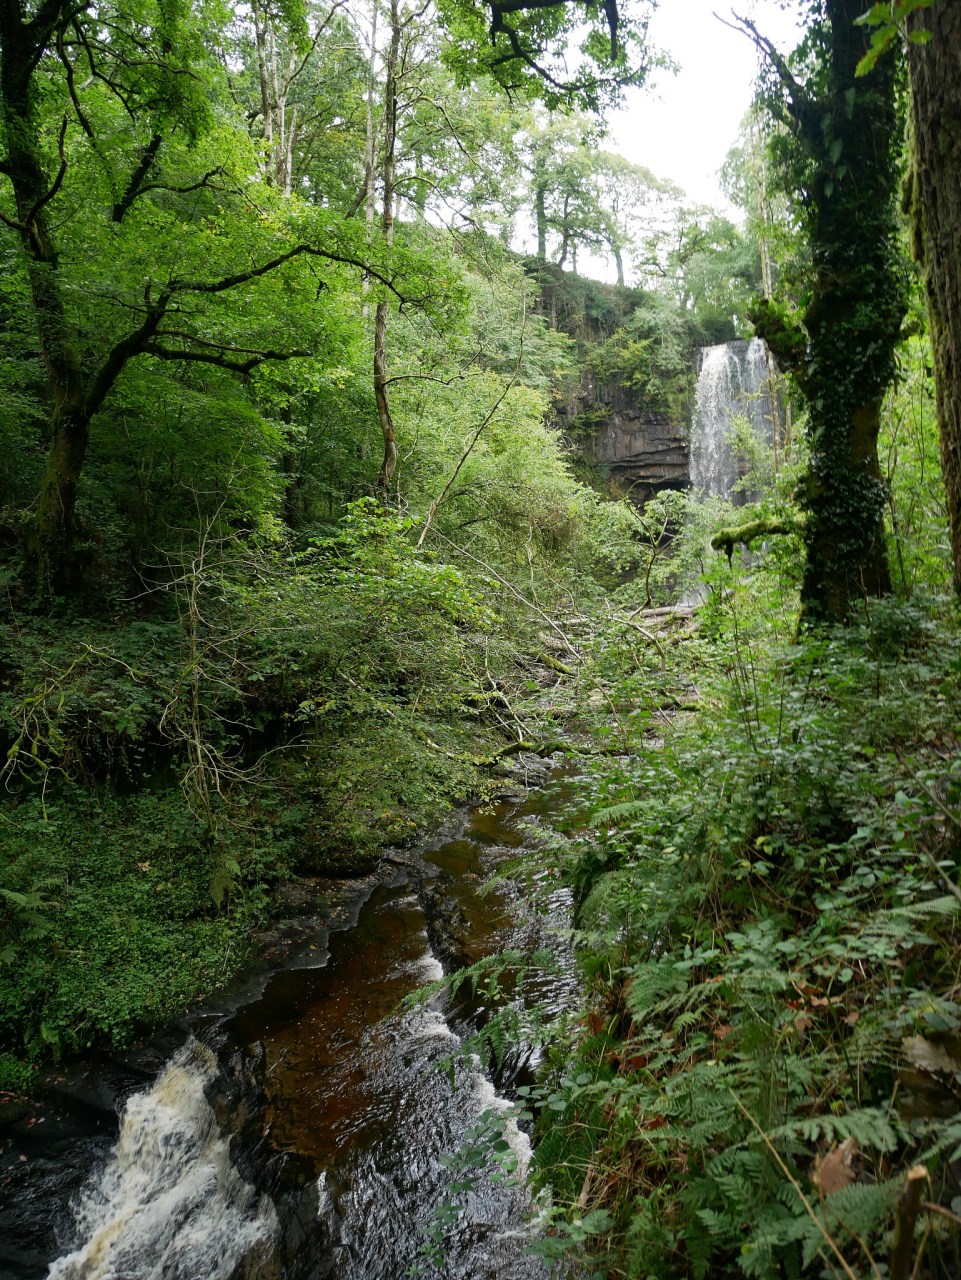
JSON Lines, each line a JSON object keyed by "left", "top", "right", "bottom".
{"left": 0, "top": 500, "right": 563, "bottom": 1070}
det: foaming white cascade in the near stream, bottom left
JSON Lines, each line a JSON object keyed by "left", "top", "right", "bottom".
{"left": 49, "top": 1041, "right": 278, "bottom": 1280}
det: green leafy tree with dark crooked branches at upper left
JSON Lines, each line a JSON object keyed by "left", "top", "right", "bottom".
{"left": 0, "top": 0, "right": 401, "bottom": 589}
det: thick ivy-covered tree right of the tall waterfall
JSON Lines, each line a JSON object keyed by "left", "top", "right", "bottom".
{"left": 740, "top": 0, "right": 906, "bottom": 620}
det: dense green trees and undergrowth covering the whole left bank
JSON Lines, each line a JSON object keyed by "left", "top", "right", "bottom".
{"left": 0, "top": 3, "right": 696, "bottom": 1064}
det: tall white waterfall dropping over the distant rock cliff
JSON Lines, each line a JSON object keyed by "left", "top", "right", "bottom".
{"left": 691, "top": 338, "right": 772, "bottom": 498}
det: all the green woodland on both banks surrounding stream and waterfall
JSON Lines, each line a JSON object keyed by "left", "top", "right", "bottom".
{"left": 0, "top": 0, "right": 961, "bottom": 1280}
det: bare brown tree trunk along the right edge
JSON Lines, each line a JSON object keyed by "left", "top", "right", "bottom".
{"left": 909, "top": 0, "right": 961, "bottom": 595}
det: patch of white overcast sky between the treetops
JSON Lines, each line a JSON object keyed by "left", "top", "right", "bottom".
{"left": 612, "top": 0, "right": 800, "bottom": 209}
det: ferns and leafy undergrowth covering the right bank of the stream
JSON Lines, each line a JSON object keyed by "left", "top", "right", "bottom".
{"left": 528, "top": 573, "right": 961, "bottom": 1280}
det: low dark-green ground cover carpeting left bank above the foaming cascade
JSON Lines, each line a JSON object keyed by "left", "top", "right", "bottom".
{"left": 0, "top": 791, "right": 259, "bottom": 1056}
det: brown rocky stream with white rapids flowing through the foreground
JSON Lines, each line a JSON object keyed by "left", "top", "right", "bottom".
{"left": 0, "top": 768, "right": 577, "bottom": 1280}
